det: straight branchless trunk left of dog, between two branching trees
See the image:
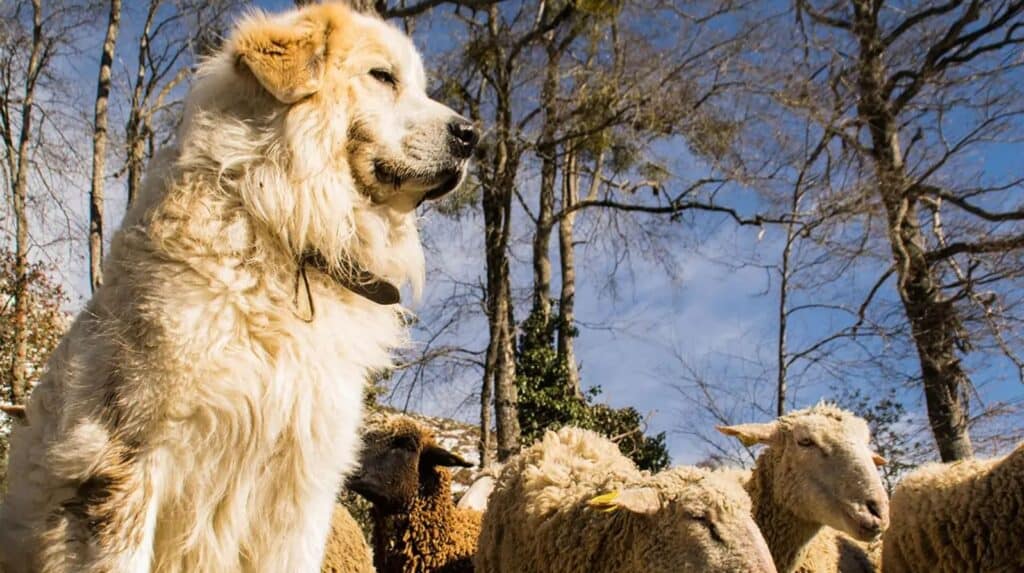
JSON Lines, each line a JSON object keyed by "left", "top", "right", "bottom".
{"left": 89, "top": 0, "right": 121, "bottom": 292}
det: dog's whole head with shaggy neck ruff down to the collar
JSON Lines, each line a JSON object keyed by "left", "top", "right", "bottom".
{"left": 182, "top": 3, "right": 478, "bottom": 292}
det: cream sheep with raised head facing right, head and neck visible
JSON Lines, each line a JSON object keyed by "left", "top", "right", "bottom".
{"left": 719, "top": 403, "right": 889, "bottom": 573}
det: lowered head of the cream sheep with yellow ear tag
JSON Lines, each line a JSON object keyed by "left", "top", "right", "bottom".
{"left": 591, "top": 468, "right": 775, "bottom": 573}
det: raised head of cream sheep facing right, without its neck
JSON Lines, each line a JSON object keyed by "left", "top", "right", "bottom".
{"left": 721, "top": 405, "right": 889, "bottom": 541}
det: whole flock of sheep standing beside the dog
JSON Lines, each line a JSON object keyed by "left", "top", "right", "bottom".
{"left": 323, "top": 404, "right": 1024, "bottom": 573}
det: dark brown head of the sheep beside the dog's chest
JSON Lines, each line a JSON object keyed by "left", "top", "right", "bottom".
{"left": 346, "top": 418, "right": 471, "bottom": 514}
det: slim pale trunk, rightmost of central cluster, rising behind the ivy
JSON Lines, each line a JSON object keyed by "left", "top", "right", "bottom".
{"left": 558, "top": 147, "right": 581, "bottom": 398}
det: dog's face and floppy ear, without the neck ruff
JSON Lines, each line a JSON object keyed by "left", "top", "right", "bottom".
{"left": 232, "top": 4, "right": 478, "bottom": 209}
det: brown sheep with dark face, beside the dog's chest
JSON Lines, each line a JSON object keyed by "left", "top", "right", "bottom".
{"left": 348, "top": 416, "right": 481, "bottom": 573}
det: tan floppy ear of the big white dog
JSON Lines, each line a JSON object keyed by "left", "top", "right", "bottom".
{"left": 234, "top": 17, "right": 329, "bottom": 103}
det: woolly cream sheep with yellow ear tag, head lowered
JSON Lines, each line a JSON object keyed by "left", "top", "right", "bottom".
{"left": 474, "top": 428, "right": 775, "bottom": 573}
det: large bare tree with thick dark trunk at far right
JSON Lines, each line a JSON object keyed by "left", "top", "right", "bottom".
{"left": 774, "top": 0, "right": 1024, "bottom": 460}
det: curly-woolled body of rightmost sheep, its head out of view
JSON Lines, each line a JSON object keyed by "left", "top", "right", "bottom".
{"left": 882, "top": 444, "right": 1024, "bottom": 573}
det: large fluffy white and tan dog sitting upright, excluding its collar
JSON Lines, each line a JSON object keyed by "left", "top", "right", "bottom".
{"left": 0, "top": 5, "right": 476, "bottom": 573}
